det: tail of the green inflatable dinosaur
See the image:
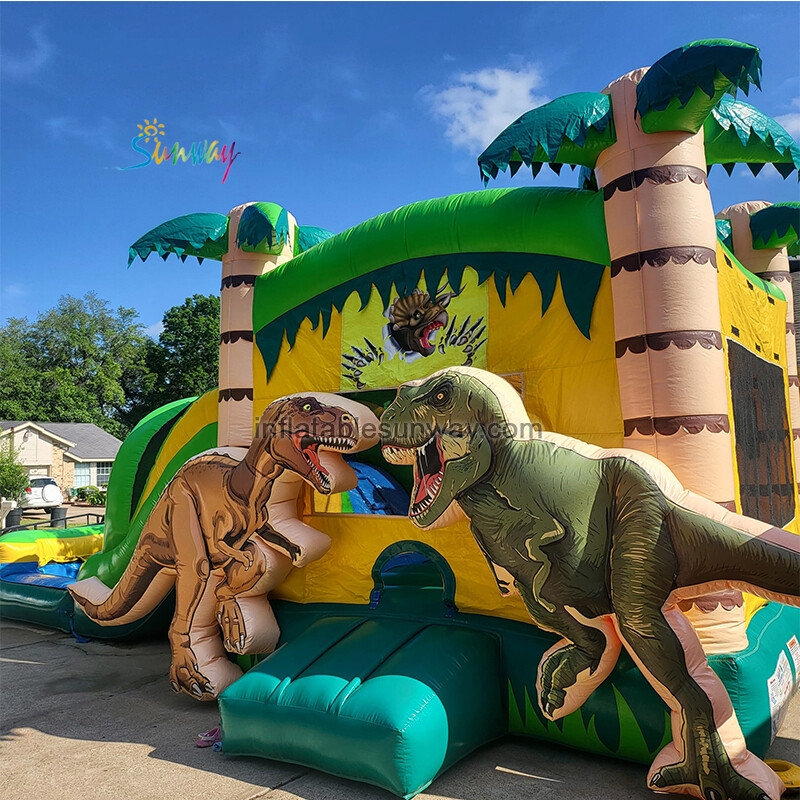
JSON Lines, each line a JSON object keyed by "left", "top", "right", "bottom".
{"left": 670, "top": 511, "right": 800, "bottom": 606}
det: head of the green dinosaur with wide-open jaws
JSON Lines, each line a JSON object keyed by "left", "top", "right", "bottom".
{"left": 381, "top": 367, "right": 530, "bottom": 528}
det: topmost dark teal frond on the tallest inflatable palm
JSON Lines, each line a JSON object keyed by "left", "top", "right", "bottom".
{"left": 636, "top": 39, "right": 761, "bottom": 133}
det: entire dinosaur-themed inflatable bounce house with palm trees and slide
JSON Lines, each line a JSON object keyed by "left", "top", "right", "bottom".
{"left": 0, "top": 40, "right": 800, "bottom": 800}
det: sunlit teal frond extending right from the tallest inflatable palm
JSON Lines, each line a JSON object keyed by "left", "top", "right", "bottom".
{"left": 704, "top": 97, "right": 800, "bottom": 180}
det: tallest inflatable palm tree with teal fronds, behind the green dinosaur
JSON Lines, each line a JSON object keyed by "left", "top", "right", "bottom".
{"left": 478, "top": 39, "right": 800, "bottom": 508}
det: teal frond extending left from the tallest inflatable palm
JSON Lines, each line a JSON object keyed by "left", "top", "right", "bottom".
{"left": 478, "top": 92, "right": 616, "bottom": 185}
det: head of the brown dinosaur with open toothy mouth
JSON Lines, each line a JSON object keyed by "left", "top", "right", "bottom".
{"left": 256, "top": 392, "right": 378, "bottom": 494}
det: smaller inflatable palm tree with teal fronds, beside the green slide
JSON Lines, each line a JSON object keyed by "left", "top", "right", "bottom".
{"left": 128, "top": 203, "right": 331, "bottom": 447}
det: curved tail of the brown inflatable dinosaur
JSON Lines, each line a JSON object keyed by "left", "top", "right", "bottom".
{"left": 67, "top": 547, "right": 175, "bottom": 625}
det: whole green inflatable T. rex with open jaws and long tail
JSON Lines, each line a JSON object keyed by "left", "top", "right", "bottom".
{"left": 381, "top": 367, "right": 800, "bottom": 800}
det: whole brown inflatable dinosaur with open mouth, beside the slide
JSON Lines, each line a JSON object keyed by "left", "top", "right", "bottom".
{"left": 69, "top": 393, "right": 378, "bottom": 700}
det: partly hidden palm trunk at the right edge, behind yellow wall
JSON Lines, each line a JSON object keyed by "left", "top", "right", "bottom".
{"left": 717, "top": 200, "right": 800, "bottom": 508}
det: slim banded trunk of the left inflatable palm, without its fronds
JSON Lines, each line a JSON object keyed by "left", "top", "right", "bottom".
{"left": 217, "top": 203, "right": 296, "bottom": 447}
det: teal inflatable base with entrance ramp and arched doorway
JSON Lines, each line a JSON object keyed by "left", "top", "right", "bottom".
{"left": 219, "top": 541, "right": 800, "bottom": 798}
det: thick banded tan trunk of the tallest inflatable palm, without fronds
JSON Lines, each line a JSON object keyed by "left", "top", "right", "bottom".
{"left": 595, "top": 69, "right": 747, "bottom": 653}
